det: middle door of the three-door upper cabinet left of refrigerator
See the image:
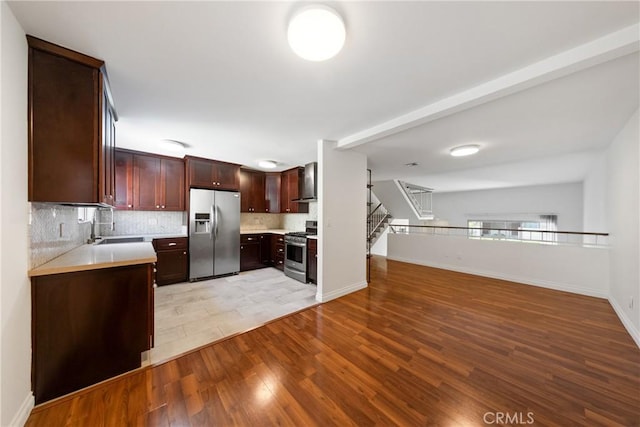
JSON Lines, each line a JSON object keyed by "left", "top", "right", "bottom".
{"left": 133, "top": 154, "right": 161, "bottom": 211}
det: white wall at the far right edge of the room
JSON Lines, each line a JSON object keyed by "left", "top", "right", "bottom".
{"left": 606, "top": 110, "right": 640, "bottom": 346}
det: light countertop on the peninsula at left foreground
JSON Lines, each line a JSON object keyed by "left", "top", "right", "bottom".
{"left": 29, "top": 244, "right": 156, "bottom": 277}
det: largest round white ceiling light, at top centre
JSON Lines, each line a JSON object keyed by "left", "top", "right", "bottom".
{"left": 287, "top": 5, "right": 347, "bottom": 61}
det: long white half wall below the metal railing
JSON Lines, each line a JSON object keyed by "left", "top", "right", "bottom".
{"left": 387, "top": 234, "right": 609, "bottom": 298}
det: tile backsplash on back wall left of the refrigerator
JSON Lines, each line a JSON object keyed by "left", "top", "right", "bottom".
{"left": 100, "top": 210, "right": 187, "bottom": 236}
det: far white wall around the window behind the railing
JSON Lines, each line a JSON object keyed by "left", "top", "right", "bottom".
{"left": 433, "top": 182, "right": 590, "bottom": 231}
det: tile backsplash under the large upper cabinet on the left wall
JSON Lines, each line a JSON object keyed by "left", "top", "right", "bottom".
{"left": 29, "top": 203, "right": 91, "bottom": 268}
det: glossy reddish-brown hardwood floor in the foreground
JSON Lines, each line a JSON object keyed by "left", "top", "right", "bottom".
{"left": 27, "top": 258, "right": 640, "bottom": 426}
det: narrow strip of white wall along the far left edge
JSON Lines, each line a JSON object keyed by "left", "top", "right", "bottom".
{"left": 0, "top": 1, "right": 33, "bottom": 426}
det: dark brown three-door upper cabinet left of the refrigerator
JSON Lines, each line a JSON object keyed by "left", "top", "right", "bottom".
{"left": 115, "top": 150, "right": 185, "bottom": 211}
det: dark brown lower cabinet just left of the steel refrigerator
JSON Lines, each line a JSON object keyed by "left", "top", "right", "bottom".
{"left": 153, "top": 237, "right": 189, "bottom": 286}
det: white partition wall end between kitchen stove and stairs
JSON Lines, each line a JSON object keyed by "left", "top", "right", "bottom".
{"left": 316, "top": 140, "right": 367, "bottom": 302}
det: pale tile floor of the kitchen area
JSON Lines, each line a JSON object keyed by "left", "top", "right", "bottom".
{"left": 143, "top": 268, "right": 316, "bottom": 365}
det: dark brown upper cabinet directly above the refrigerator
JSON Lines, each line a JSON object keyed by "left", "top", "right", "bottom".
{"left": 184, "top": 156, "right": 240, "bottom": 191}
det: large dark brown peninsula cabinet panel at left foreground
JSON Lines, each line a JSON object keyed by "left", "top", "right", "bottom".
{"left": 31, "top": 264, "right": 153, "bottom": 404}
